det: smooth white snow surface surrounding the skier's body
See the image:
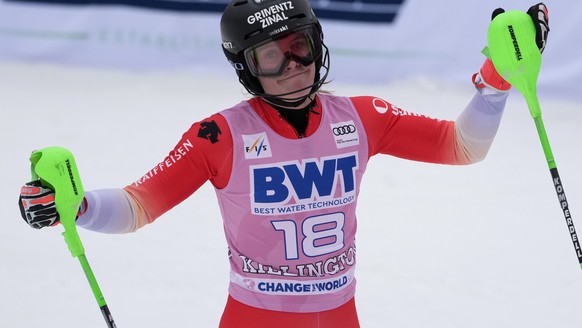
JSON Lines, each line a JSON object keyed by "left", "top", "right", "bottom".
{"left": 0, "top": 63, "right": 582, "bottom": 328}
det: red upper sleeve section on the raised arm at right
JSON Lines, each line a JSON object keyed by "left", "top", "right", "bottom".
{"left": 351, "top": 96, "right": 467, "bottom": 164}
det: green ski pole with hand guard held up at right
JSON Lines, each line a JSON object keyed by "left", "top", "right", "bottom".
{"left": 484, "top": 10, "right": 582, "bottom": 269}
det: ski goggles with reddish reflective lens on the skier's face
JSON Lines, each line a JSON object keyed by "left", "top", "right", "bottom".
{"left": 244, "top": 26, "right": 321, "bottom": 76}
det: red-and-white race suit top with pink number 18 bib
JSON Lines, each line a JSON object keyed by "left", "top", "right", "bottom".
{"left": 77, "top": 91, "right": 507, "bottom": 313}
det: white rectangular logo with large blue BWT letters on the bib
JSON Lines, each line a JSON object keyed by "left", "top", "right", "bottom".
{"left": 250, "top": 152, "right": 358, "bottom": 208}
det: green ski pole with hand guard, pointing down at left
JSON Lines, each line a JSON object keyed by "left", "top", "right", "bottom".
{"left": 30, "top": 147, "right": 116, "bottom": 328}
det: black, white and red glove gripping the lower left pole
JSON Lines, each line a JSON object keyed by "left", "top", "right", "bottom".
{"left": 18, "top": 180, "right": 60, "bottom": 229}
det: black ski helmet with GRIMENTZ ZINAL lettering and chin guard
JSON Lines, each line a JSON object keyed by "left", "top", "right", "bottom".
{"left": 220, "top": 0, "right": 329, "bottom": 103}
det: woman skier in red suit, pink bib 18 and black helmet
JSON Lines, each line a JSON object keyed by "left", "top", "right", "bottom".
{"left": 19, "top": 0, "right": 548, "bottom": 328}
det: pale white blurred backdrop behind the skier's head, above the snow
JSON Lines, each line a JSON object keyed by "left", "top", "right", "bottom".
{"left": 0, "top": 0, "right": 582, "bottom": 97}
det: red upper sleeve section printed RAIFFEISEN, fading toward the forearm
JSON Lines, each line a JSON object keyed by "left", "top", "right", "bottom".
{"left": 124, "top": 114, "right": 233, "bottom": 223}
